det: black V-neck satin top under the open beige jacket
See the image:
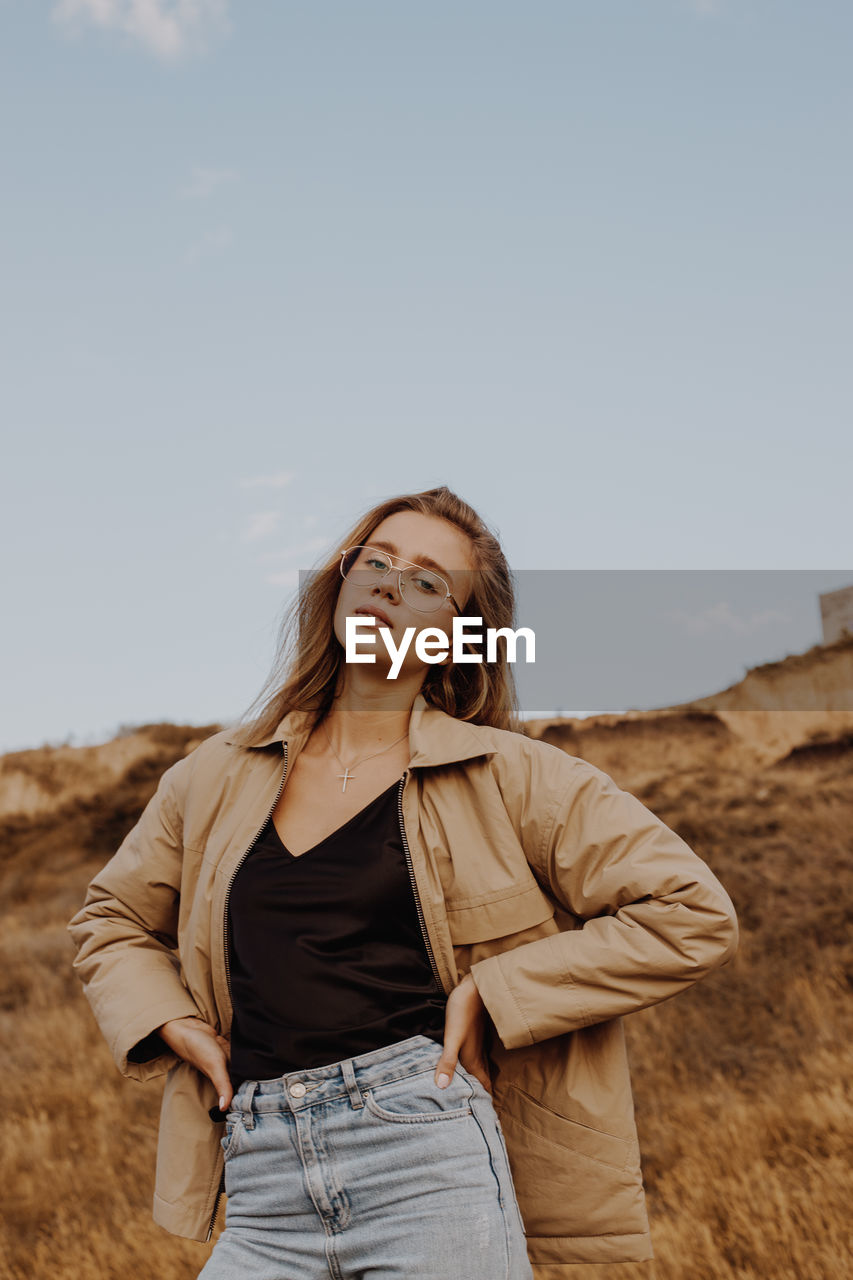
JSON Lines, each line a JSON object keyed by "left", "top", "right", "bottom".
{"left": 228, "top": 782, "right": 447, "bottom": 1088}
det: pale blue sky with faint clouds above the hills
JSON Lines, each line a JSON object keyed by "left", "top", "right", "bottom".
{"left": 0, "top": 0, "right": 853, "bottom": 750}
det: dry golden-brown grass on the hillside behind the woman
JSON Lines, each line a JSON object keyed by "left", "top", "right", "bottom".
{"left": 0, "top": 724, "right": 853, "bottom": 1280}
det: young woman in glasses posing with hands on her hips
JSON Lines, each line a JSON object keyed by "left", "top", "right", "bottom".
{"left": 69, "top": 488, "right": 736, "bottom": 1280}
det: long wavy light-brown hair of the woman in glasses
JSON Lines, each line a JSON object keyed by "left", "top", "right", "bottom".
{"left": 236, "top": 485, "right": 519, "bottom": 745}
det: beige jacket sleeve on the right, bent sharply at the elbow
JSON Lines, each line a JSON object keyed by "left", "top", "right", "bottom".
{"left": 471, "top": 758, "right": 738, "bottom": 1048}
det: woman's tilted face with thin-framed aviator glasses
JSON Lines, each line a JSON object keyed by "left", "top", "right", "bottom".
{"left": 334, "top": 511, "right": 474, "bottom": 675}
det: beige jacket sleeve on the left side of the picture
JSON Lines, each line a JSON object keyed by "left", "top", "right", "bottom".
{"left": 68, "top": 759, "right": 199, "bottom": 1080}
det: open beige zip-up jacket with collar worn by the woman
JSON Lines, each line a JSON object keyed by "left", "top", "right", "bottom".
{"left": 69, "top": 696, "right": 736, "bottom": 1280}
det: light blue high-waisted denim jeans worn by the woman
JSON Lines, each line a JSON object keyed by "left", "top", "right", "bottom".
{"left": 199, "top": 1036, "right": 533, "bottom": 1280}
